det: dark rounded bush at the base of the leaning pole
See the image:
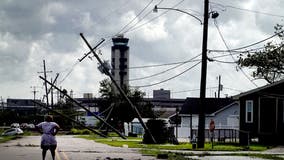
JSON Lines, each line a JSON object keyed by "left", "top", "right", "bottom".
{"left": 143, "top": 119, "right": 169, "bottom": 144}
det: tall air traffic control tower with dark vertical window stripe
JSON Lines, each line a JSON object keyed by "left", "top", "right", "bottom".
{"left": 111, "top": 35, "right": 129, "bottom": 91}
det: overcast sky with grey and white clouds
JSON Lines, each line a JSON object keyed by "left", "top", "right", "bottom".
{"left": 0, "top": 0, "right": 284, "bottom": 99}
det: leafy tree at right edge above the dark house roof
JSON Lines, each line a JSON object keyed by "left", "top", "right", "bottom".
{"left": 238, "top": 24, "right": 284, "bottom": 83}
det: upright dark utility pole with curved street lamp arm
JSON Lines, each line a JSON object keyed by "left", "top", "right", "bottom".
{"left": 153, "top": 0, "right": 219, "bottom": 148}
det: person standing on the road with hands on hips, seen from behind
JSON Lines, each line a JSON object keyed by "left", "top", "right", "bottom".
{"left": 36, "top": 115, "right": 60, "bottom": 160}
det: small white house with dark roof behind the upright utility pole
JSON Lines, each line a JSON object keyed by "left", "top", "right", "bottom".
{"left": 175, "top": 98, "right": 239, "bottom": 138}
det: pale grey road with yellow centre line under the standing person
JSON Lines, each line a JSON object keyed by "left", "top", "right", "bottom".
{"left": 0, "top": 136, "right": 155, "bottom": 160}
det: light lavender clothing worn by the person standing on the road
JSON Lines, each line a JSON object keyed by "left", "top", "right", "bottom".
{"left": 37, "top": 122, "right": 59, "bottom": 145}
